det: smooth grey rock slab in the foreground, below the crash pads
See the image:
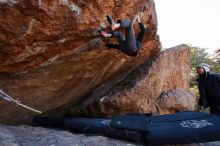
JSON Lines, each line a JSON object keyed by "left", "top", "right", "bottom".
{"left": 0, "top": 125, "right": 141, "bottom": 146}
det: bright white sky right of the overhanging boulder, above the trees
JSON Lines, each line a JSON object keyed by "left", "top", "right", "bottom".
{"left": 154, "top": 0, "right": 220, "bottom": 53}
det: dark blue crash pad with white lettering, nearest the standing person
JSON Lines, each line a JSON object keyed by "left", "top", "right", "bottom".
{"left": 145, "top": 112, "right": 220, "bottom": 145}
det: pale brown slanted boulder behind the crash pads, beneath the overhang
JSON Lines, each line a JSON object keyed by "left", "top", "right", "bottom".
{"left": 71, "top": 45, "right": 195, "bottom": 117}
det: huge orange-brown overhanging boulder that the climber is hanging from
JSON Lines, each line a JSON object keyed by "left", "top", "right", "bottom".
{"left": 0, "top": 0, "right": 161, "bottom": 124}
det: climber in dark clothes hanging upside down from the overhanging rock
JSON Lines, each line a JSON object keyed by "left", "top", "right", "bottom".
{"left": 99, "top": 15, "right": 145, "bottom": 56}
